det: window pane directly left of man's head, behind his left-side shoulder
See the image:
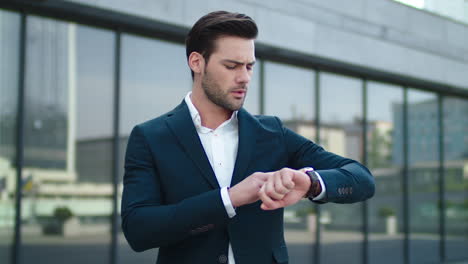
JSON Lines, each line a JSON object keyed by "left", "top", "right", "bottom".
{"left": 118, "top": 35, "right": 192, "bottom": 263}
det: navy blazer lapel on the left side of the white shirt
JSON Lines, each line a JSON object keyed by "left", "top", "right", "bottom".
{"left": 166, "top": 102, "right": 220, "bottom": 189}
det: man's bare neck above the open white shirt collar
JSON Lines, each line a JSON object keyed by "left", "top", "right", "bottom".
{"left": 190, "top": 88, "right": 233, "bottom": 129}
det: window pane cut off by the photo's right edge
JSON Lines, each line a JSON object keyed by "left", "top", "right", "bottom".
{"left": 443, "top": 97, "right": 468, "bottom": 260}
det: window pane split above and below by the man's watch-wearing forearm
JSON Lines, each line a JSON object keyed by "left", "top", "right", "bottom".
{"left": 319, "top": 73, "right": 363, "bottom": 264}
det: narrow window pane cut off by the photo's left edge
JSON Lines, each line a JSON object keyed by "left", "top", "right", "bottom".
{"left": 0, "top": 10, "right": 20, "bottom": 263}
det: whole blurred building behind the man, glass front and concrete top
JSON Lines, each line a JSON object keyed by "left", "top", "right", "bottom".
{"left": 0, "top": 0, "right": 468, "bottom": 264}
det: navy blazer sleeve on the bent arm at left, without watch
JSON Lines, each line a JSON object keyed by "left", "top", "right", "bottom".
{"left": 121, "top": 126, "right": 229, "bottom": 251}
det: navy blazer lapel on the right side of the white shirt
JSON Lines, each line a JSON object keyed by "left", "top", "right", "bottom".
{"left": 231, "top": 108, "right": 257, "bottom": 186}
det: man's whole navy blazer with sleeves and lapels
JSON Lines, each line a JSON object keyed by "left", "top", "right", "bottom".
{"left": 122, "top": 102, "right": 374, "bottom": 264}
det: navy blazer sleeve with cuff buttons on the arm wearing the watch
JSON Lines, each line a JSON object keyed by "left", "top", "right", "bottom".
{"left": 278, "top": 119, "right": 375, "bottom": 203}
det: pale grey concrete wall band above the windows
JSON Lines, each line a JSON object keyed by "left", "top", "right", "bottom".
{"left": 67, "top": 0, "right": 468, "bottom": 89}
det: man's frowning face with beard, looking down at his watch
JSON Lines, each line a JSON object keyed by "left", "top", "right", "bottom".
{"left": 202, "top": 36, "right": 255, "bottom": 111}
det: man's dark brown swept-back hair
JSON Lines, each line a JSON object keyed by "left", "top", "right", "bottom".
{"left": 185, "top": 11, "right": 258, "bottom": 78}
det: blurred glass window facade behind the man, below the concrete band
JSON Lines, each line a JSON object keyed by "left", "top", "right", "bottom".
{"left": 0, "top": 2, "right": 468, "bottom": 264}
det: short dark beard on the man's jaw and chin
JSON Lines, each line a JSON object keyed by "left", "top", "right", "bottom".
{"left": 201, "top": 71, "right": 247, "bottom": 111}
